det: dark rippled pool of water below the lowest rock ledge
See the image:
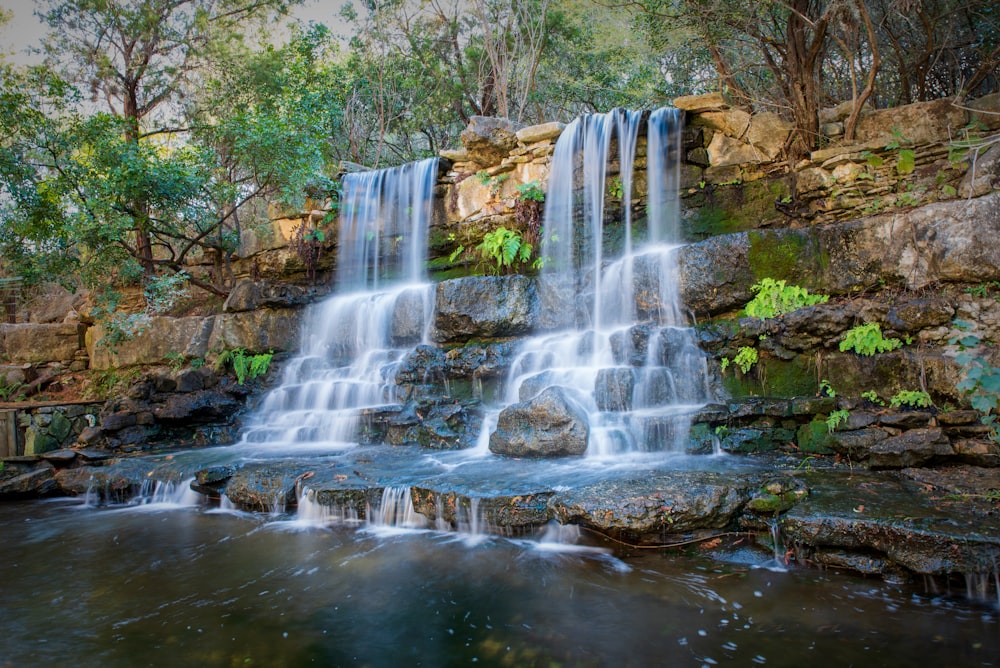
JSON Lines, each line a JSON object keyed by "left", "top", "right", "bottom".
{"left": 0, "top": 501, "right": 1000, "bottom": 667}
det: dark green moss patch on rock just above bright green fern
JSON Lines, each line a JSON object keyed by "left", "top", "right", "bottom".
{"left": 747, "top": 230, "right": 830, "bottom": 289}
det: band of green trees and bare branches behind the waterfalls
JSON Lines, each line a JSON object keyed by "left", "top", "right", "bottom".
{"left": 0, "top": 0, "right": 1000, "bottom": 336}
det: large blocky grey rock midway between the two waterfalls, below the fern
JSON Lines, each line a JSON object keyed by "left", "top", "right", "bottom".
{"left": 431, "top": 275, "right": 538, "bottom": 343}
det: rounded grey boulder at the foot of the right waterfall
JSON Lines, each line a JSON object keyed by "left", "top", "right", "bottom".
{"left": 490, "top": 387, "right": 590, "bottom": 457}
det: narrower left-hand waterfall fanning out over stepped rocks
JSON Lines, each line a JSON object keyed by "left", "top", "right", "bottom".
{"left": 243, "top": 158, "right": 438, "bottom": 451}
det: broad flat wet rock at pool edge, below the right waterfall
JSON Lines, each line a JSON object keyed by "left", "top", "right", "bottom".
{"left": 550, "top": 471, "right": 759, "bottom": 544}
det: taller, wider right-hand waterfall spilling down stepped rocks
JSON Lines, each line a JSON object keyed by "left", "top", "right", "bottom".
{"left": 505, "top": 109, "right": 711, "bottom": 456}
